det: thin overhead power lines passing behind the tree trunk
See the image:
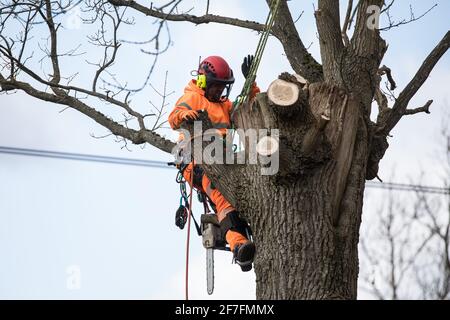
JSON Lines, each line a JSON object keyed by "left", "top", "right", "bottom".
{"left": 0, "top": 146, "right": 450, "bottom": 195}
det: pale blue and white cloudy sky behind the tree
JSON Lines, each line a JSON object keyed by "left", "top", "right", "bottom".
{"left": 0, "top": 0, "right": 450, "bottom": 299}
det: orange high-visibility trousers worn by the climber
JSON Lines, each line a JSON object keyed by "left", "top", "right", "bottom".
{"left": 183, "top": 162, "right": 248, "bottom": 251}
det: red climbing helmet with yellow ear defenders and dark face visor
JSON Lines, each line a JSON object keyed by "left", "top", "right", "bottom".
{"left": 197, "top": 56, "right": 234, "bottom": 102}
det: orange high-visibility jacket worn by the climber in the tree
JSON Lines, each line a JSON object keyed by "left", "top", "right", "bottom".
{"left": 169, "top": 80, "right": 260, "bottom": 135}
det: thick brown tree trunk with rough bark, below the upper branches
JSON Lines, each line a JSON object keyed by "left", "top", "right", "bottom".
{"left": 224, "top": 74, "right": 368, "bottom": 299}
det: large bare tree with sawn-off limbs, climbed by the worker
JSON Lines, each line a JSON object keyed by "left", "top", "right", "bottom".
{"left": 0, "top": 0, "right": 450, "bottom": 299}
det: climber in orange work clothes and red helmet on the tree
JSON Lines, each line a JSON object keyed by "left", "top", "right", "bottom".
{"left": 169, "top": 56, "right": 259, "bottom": 271}
